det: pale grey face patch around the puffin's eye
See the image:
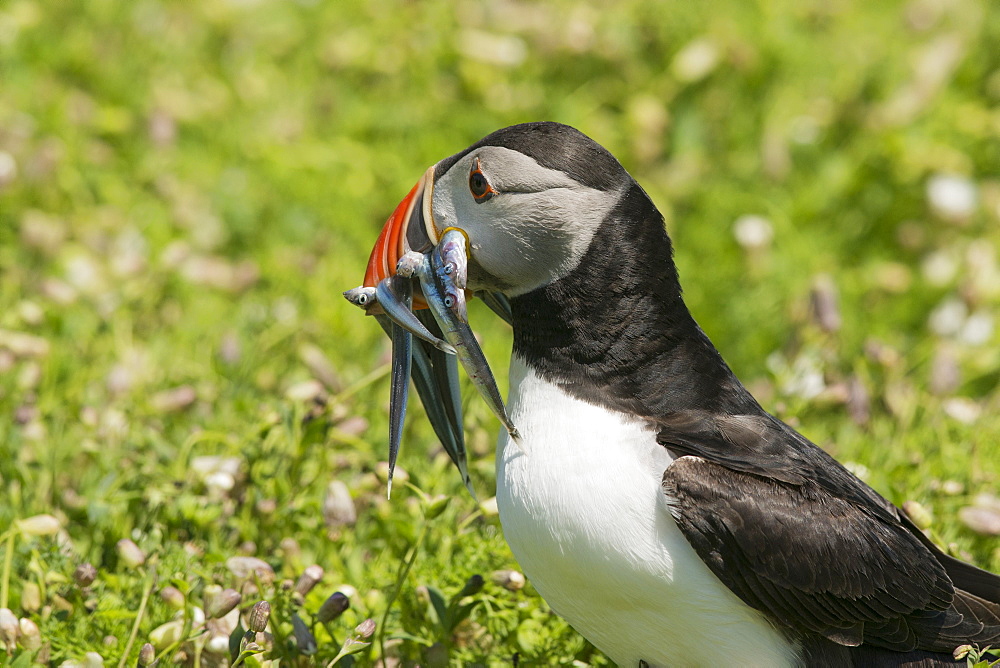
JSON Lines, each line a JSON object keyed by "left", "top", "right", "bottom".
{"left": 432, "top": 146, "right": 627, "bottom": 296}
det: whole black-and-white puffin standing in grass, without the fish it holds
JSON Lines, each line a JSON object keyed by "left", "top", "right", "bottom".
{"left": 358, "top": 122, "right": 1000, "bottom": 668}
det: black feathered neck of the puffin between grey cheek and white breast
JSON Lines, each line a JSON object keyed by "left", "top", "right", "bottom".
{"left": 511, "top": 182, "right": 760, "bottom": 420}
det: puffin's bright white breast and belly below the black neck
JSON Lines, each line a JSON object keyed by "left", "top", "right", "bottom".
{"left": 497, "top": 357, "right": 796, "bottom": 668}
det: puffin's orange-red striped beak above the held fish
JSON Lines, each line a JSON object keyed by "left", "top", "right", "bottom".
{"left": 364, "top": 167, "right": 438, "bottom": 308}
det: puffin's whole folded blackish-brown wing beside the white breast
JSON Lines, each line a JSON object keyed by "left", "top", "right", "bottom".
{"left": 658, "top": 414, "right": 1000, "bottom": 652}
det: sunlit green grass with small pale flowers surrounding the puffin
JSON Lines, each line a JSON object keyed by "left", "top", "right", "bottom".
{"left": 0, "top": 0, "right": 1000, "bottom": 666}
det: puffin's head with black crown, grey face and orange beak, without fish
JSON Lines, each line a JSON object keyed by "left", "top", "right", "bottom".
{"left": 364, "top": 122, "right": 635, "bottom": 297}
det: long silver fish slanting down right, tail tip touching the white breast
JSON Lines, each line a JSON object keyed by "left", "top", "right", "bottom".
{"left": 397, "top": 251, "right": 521, "bottom": 443}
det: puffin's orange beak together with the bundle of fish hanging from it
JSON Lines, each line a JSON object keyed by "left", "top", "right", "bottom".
{"left": 344, "top": 167, "right": 520, "bottom": 498}
